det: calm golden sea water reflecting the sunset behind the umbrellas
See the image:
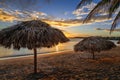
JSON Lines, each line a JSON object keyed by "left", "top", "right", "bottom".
{"left": 0, "top": 39, "right": 120, "bottom": 58}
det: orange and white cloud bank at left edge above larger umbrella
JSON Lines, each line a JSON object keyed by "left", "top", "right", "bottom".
{"left": 0, "top": 8, "right": 49, "bottom": 21}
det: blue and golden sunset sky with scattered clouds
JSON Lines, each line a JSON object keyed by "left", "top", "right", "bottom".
{"left": 0, "top": 0, "right": 120, "bottom": 37}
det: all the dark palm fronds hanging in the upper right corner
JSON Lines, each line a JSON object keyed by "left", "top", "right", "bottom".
{"left": 77, "top": 0, "right": 120, "bottom": 32}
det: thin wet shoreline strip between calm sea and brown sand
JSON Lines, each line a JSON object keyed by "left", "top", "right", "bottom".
{"left": 0, "top": 50, "right": 73, "bottom": 61}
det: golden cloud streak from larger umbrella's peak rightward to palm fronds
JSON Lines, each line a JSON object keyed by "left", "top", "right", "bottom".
{"left": 43, "top": 16, "right": 108, "bottom": 27}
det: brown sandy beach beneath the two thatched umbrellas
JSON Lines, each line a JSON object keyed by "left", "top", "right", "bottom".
{"left": 0, "top": 47, "right": 120, "bottom": 80}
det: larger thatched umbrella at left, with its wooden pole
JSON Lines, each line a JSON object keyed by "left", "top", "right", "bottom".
{"left": 0, "top": 20, "right": 69, "bottom": 73}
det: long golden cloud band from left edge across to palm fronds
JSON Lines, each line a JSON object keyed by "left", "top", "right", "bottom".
{"left": 0, "top": 9, "right": 111, "bottom": 27}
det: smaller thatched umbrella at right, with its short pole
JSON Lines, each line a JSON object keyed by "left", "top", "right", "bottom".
{"left": 74, "top": 37, "right": 116, "bottom": 59}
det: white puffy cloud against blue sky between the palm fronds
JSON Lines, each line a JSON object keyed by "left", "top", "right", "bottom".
{"left": 72, "top": 2, "right": 115, "bottom": 22}
